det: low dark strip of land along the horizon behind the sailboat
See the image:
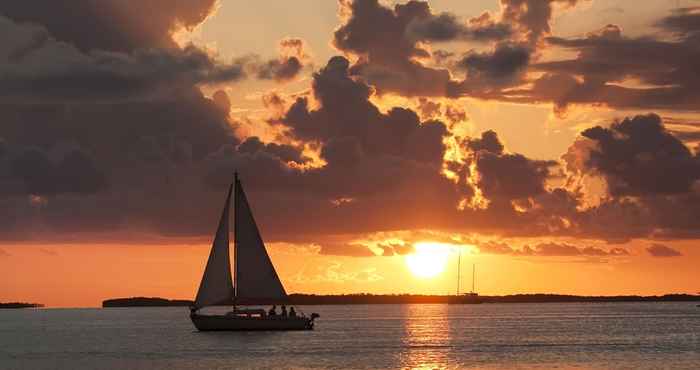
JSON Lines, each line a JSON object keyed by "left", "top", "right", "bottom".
{"left": 102, "top": 294, "right": 700, "bottom": 308}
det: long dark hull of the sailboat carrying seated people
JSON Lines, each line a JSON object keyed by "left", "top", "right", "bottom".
{"left": 190, "top": 314, "right": 314, "bottom": 331}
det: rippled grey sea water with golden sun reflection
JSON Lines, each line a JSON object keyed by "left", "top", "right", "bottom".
{"left": 0, "top": 303, "right": 700, "bottom": 370}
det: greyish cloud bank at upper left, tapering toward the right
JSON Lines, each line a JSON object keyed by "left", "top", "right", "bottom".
{"left": 0, "top": 16, "right": 245, "bottom": 102}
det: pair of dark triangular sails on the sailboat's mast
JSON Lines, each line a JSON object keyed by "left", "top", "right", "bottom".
{"left": 194, "top": 176, "right": 287, "bottom": 309}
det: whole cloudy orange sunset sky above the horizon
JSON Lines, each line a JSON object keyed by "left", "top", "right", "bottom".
{"left": 0, "top": 0, "right": 700, "bottom": 307}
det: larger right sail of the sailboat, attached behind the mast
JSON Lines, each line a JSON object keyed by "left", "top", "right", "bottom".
{"left": 234, "top": 178, "right": 287, "bottom": 304}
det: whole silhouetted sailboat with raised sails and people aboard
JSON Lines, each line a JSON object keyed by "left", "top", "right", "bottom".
{"left": 190, "top": 174, "right": 319, "bottom": 331}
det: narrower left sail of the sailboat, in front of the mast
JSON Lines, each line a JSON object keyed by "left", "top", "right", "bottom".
{"left": 194, "top": 186, "right": 234, "bottom": 309}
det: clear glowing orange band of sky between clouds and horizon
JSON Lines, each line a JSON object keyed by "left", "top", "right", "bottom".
{"left": 0, "top": 243, "right": 700, "bottom": 307}
